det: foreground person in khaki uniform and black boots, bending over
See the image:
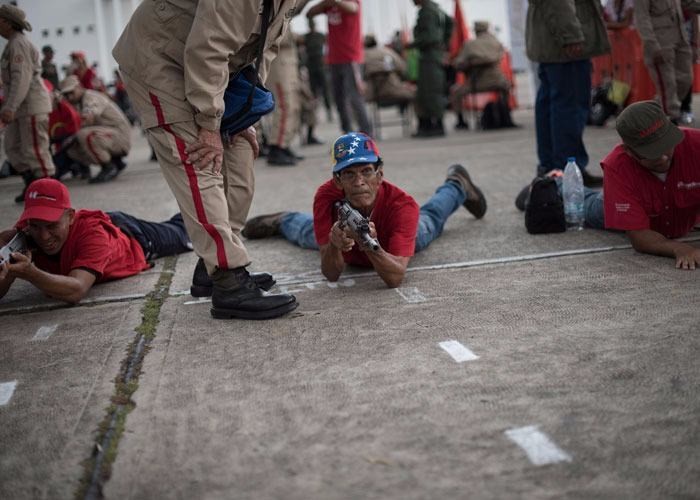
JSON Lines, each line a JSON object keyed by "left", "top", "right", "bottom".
{"left": 112, "top": 0, "right": 297, "bottom": 319}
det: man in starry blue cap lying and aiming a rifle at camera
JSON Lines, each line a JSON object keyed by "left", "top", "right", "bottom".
{"left": 242, "top": 132, "right": 486, "bottom": 288}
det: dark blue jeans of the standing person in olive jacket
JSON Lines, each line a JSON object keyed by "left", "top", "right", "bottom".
{"left": 535, "top": 59, "right": 591, "bottom": 176}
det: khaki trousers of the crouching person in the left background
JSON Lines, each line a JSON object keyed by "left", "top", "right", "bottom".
{"left": 68, "top": 126, "right": 131, "bottom": 165}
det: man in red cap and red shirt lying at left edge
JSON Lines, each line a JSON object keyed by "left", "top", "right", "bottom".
{"left": 0, "top": 178, "right": 192, "bottom": 304}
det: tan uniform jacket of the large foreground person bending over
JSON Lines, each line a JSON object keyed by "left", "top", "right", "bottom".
{"left": 112, "top": 0, "right": 296, "bottom": 130}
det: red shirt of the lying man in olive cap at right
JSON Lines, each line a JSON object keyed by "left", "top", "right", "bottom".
{"left": 601, "top": 129, "right": 700, "bottom": 238}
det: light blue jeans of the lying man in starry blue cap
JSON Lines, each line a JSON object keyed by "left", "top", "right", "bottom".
{"left": 280, "top": 181, "right": 467, "bottom": 252}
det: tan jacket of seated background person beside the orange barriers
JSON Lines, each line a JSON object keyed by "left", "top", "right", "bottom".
{"left": 454, "top": 33, "right": 510, "bottom": 92}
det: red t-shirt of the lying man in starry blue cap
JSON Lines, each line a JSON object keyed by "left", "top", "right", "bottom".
{"left": 314, "top": 180, "right": 420, "bottom": 267}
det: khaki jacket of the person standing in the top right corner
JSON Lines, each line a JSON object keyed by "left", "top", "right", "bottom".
{"left": 634, "top": 0, "right": 700, "bottom": 55}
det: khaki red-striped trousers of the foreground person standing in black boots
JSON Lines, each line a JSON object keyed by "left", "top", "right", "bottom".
{"left": 146, "top": 121, "right": 254, "bottom": 274}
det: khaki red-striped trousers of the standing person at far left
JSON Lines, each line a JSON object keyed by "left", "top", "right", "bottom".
{"left": 4, "top": 115, "right": 55, "bottom": 177}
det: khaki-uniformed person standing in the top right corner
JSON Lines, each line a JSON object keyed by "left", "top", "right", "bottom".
{"left": 634, "top": 0, "right": 700, "bottom": 123}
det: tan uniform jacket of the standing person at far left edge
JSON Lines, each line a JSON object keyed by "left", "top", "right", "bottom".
{"left": 0, "top": 33, "right": 51, "bottom": 118}
